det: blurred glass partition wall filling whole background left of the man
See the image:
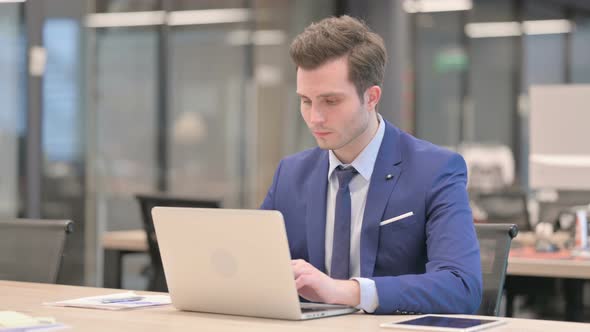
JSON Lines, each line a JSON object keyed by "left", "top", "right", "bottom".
{"left": 0, "top": 0, "right": 334, "bottom": 288}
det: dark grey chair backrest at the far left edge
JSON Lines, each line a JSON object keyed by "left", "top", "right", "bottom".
{"left": 0, "top": 219, "right": 73, "bottom": 283}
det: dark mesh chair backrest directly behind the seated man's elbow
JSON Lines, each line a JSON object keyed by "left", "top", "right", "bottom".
{"left": 475, "top": 224, "right": 518, "bottom": 316}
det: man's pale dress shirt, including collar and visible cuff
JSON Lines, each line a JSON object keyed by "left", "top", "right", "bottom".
{"left": 325, "top": 114, "right": 385, "bottom": 312}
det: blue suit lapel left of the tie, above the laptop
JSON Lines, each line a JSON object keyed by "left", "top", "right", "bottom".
{"left": 306, "top": 151, "right": 329, "bottom": 273}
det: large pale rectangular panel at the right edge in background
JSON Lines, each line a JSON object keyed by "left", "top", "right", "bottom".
{"left": 529, "top": 85, "right": 590, "bottom": 191}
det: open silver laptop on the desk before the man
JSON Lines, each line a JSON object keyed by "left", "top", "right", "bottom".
{"left": 152, "top": 207, "right": 357, "bottom": 320}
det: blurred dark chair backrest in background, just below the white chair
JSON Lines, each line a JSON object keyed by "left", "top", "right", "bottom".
{"left": 471, "top": 190, "right": 531, "bottom": 231}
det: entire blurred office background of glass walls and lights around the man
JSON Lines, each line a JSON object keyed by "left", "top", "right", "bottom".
{"left": 0, "top": 0, "right": 590, "bottom": 320}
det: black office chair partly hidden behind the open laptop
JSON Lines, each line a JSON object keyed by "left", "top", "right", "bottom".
{"left": 135, "top": 194, "right": 220, "bottom": 292}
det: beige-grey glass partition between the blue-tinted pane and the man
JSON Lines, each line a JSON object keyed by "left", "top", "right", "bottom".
{"left": 85, "top": 0, "right": 333, "bottom": 284}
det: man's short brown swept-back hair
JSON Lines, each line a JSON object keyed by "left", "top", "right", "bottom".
{"left": 289, "top": 15, "right": 387, "bottom": 100}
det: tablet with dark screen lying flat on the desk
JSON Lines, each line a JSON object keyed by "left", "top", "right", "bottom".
{"left": 381, "top": 315, "right": 505, "bottom": 332}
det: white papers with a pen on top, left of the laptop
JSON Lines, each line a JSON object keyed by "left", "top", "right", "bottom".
{"left": 44, "top": 292, "right": 172, "bottom": 310}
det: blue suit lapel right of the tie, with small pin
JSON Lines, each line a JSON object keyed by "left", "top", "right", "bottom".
{"left": 361, "top": 121, "right": 402, "bottom": 278}
